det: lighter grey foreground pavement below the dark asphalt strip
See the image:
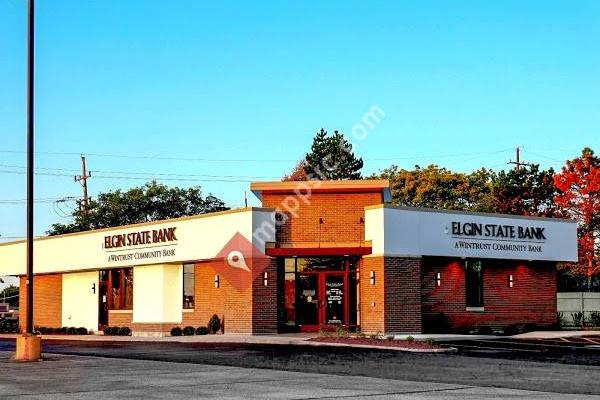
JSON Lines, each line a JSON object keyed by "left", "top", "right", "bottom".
{"left": 0, "top": 351, "right": 596, "bottom": 400}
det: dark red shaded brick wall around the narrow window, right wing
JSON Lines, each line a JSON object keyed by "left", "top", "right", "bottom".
{"left": 422, "top": 258, "right": 556, "bottom": 330}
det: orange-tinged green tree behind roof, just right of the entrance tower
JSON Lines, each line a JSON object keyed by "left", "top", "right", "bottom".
{"left": 373, "top": 165, "right": 491, "bottom": 211}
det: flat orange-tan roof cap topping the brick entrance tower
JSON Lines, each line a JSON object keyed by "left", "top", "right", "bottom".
{"left": 250, "top": 179, "right": 392, "bottom": 201}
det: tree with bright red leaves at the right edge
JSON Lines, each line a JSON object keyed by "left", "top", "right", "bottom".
{"left": 554, "top": 147, "right": 600, "bottom": 290}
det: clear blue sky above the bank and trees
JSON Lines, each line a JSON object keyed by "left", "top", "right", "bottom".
{"left": 0, "top": 0, "right": 600, "bottom": 238}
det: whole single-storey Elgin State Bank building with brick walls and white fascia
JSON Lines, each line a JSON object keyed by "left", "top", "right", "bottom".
{"left": 0, "top": 180, "right": 577, "bottom": 336}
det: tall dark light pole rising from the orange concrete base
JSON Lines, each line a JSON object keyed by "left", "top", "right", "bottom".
{"left": 26, "top": 0, "right": 35, "bottom": 333}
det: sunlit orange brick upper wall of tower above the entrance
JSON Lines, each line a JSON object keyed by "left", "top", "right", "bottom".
{"left": 262, "top": 192, "right": 383, "bottom": 243}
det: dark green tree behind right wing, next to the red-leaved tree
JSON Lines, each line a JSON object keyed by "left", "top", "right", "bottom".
{"left": 491, "top": 164, "right": 557, "bottom": 217}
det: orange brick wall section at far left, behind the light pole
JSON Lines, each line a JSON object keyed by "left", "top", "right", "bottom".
{"left": 19, "top": 274, "right": 62, "bottom": 331}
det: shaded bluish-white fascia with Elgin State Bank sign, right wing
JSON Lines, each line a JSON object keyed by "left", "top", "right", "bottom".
{"left": 365, "top": 207, "right": 577, "bottom": 261}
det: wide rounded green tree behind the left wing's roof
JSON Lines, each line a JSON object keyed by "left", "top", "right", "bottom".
{"left": 47, "top": 181, "right": 228, "bottom": 235}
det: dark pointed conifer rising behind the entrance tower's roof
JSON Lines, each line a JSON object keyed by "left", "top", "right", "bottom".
{"left": 304, "top": 128, "right": 363, "bottom": 180}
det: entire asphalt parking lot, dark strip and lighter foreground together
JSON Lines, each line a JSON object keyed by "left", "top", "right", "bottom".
{"left": 0, "top": 339, "right": 600, "bottom": 398}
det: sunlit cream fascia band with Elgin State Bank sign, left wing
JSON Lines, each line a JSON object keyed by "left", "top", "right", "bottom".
{"left": 0, "top": 208, "right": 275, "bottom": 276}
